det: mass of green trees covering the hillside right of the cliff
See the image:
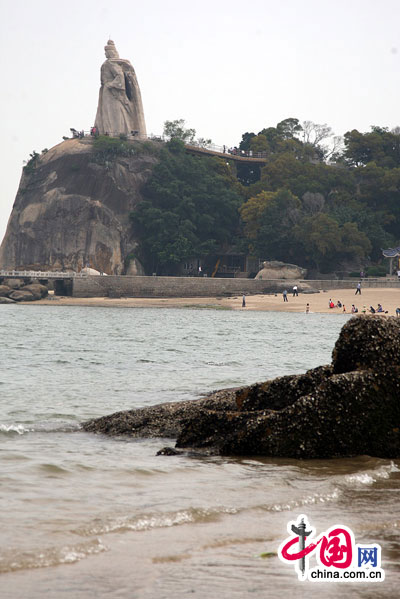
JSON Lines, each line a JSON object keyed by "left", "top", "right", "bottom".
{"left": 132, "top": 117, "right": 400, "bottom": 273}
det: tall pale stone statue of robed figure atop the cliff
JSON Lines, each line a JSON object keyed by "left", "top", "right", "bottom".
{"left": 95, "top": 40, "right": 146, "bottom": 137}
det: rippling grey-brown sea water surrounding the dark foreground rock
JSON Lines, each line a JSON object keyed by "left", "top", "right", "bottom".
{"left": 0, "top": 305, "right": 400, "bottom": 599}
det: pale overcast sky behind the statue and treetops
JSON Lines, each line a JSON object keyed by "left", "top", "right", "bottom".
{"left": 0, "top": 0, "right": 400, "bottom": 241}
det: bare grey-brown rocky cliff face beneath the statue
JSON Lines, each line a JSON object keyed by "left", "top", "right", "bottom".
{"left": 0, "top": 138, "right": 159, "bottom": 274}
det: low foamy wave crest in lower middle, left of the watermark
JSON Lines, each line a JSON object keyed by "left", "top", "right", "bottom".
{"left": 74, "top": 507, "right": 240, "bottom": 537}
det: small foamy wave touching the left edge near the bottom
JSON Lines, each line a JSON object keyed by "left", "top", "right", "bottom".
{"left": 0, "top": 539, "right": 108, "bottom": 574}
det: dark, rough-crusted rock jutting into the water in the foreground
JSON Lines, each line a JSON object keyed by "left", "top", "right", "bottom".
{"left": 83, "top": 316, "right": 400, "bottom": 458}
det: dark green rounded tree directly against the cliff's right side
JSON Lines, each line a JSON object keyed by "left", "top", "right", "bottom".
{"left": 131, "top": 138, "right": 242, "bottom": 274}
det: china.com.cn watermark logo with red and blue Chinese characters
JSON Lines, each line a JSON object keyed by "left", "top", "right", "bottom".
{"left": 278, "top": 514, "right": 385, "bottom": 582}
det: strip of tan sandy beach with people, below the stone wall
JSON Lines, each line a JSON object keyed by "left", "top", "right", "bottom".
{"left": 26, "top": 288, "right": 400, "bottom": 316}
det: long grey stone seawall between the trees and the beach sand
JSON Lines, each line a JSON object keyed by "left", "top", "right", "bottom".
{"left": 72, "top": 275, "right": 400, "bottom": 297}
